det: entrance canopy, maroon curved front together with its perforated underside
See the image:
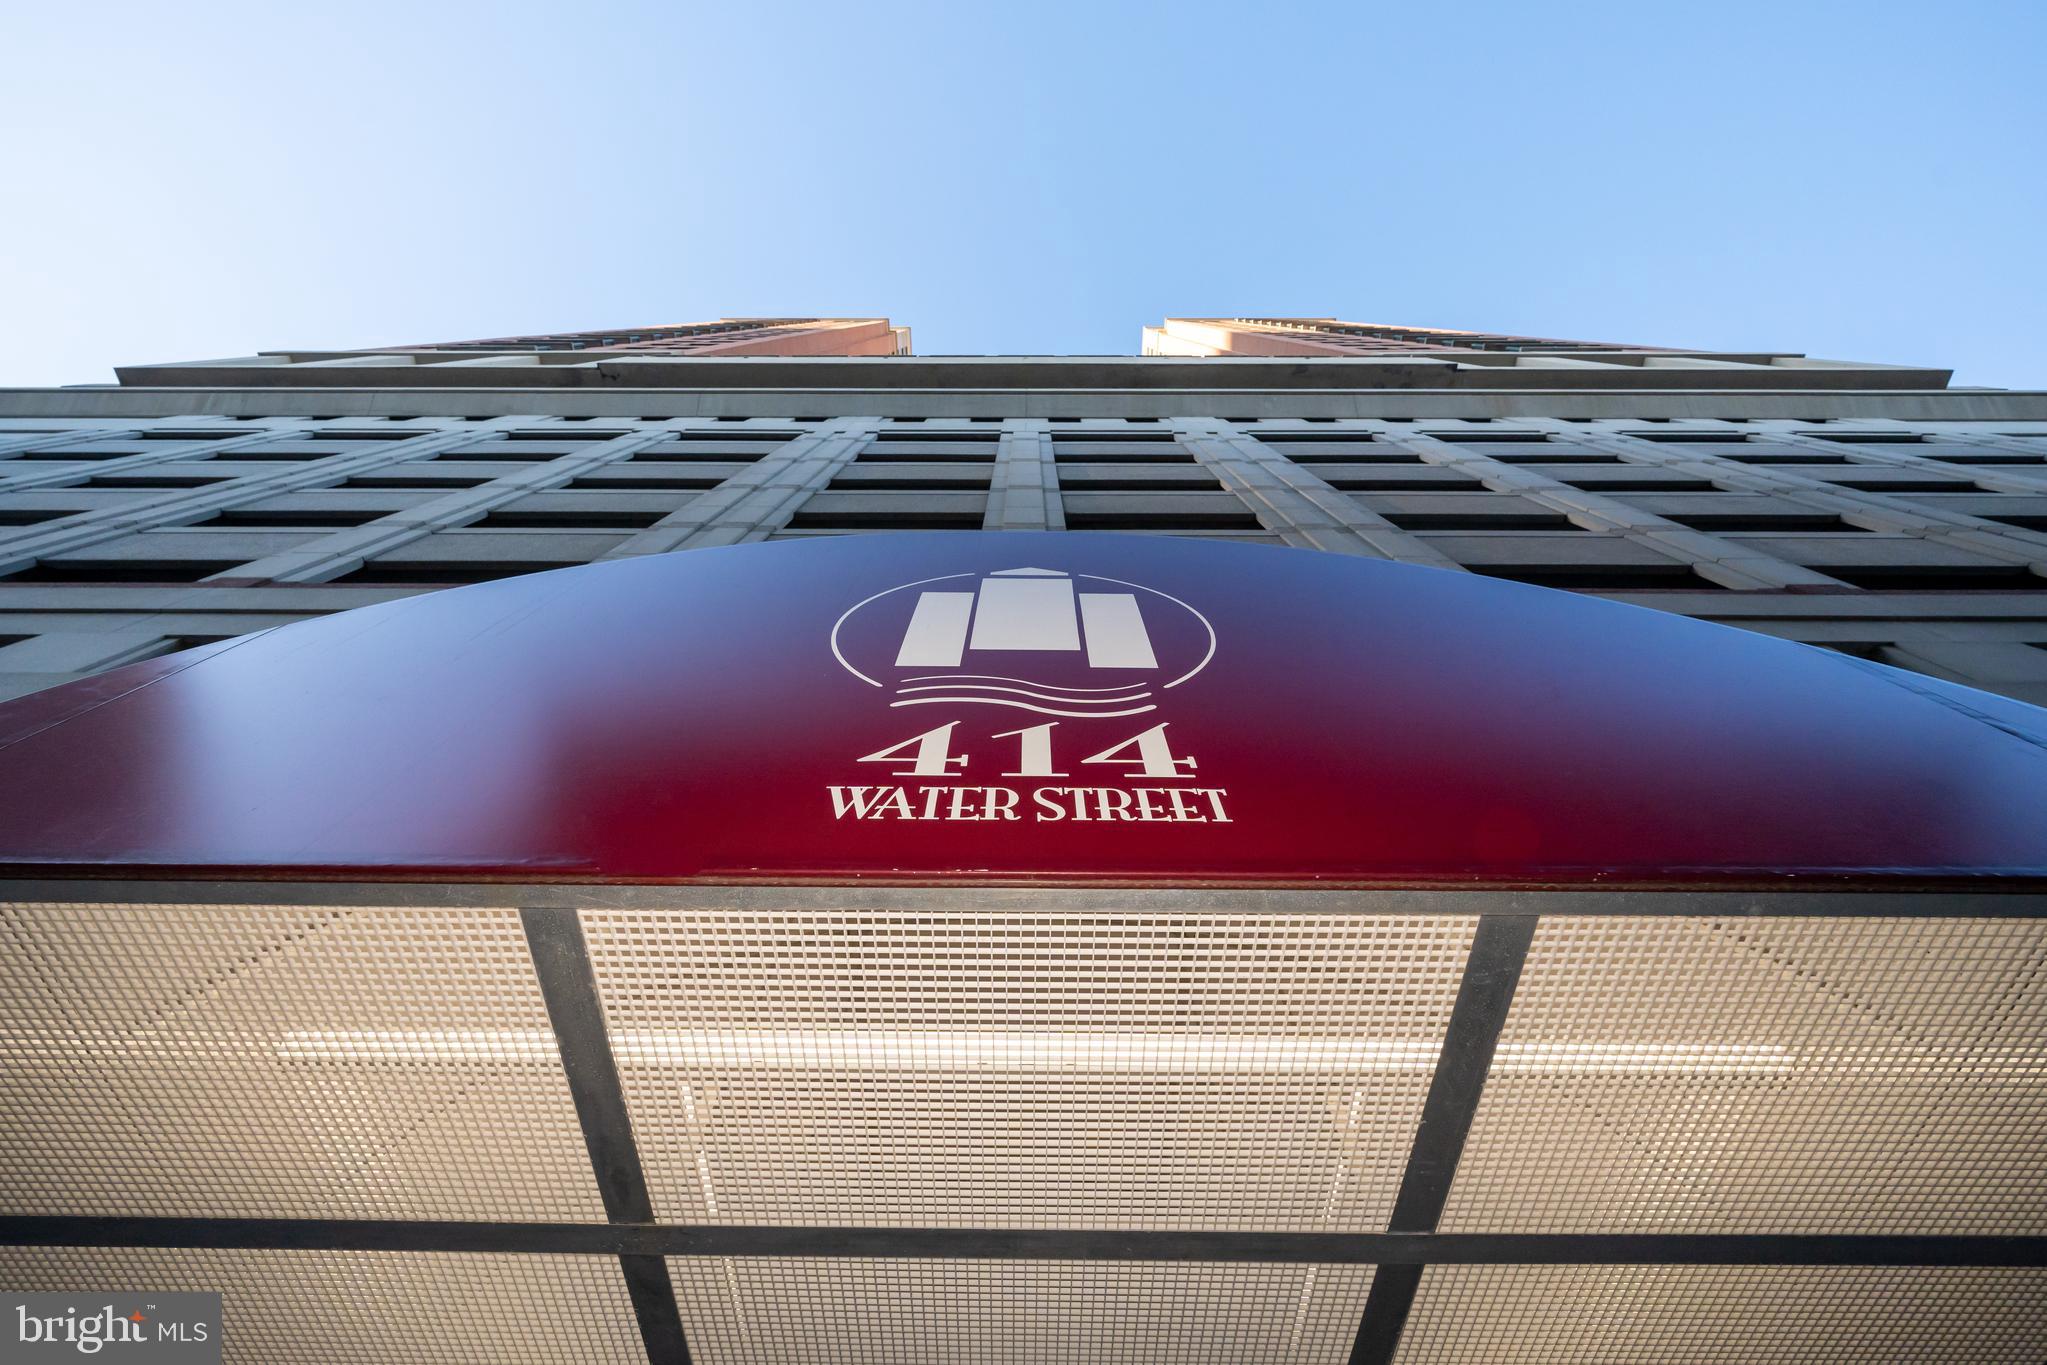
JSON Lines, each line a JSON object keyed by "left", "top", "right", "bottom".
{"left": 0, "top": 536, "right": 2047, "bottom": 1365}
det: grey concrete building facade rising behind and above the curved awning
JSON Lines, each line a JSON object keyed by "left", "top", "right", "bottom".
{"left": 0, "top": 319, "right": 2047, "bottom": 704}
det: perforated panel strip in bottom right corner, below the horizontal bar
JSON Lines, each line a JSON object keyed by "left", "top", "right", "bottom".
{"left": 1394, "top": 1265, "right": 2047, "bottom": 1365}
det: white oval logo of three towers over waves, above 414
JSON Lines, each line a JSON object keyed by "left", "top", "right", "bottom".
{"left": 831, "top": 569, "right": 1216, "bottom": 718}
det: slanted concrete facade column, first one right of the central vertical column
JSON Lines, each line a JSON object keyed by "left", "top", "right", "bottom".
{"left": 1171, "top": 417, "right": 1464, "bottom": 571}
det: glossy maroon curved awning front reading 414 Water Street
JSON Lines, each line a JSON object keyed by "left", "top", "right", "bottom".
{"left": 0, "top": 532, "right": 2047, "bottom": 886}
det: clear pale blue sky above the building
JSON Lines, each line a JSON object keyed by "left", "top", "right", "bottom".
{"left": 0, "top": 0, "right": 2047, "bottom": 387}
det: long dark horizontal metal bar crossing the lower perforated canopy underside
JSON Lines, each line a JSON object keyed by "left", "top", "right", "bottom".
{"left": 0, "top": 1216, "right": 2047, "bottom": 1269}
